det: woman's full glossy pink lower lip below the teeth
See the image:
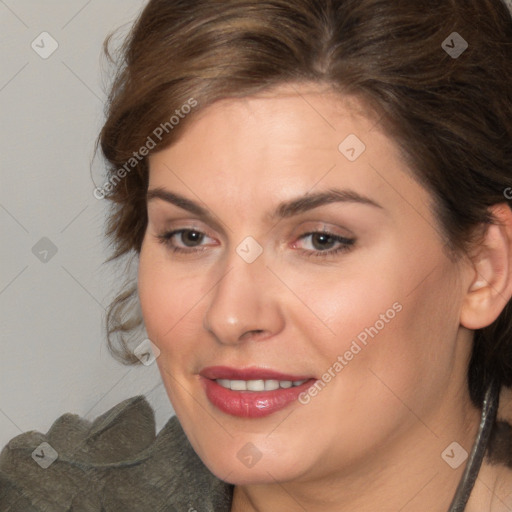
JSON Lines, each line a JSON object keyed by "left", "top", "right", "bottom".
{"left": 201, "top": 377, "right": 315, "bottom": 418}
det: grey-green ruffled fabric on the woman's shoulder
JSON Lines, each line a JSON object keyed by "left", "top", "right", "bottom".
{"left": 0, "top": 395, "right": 232, "bottom": 512}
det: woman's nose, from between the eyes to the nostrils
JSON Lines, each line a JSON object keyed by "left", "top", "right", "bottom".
{"left": 203, "top": 254, "right": 284, "bottom": 345}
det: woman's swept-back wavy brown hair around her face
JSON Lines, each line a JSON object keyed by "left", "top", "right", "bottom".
{"left": 98, "top": 0, "right": 512, "bottom": 405}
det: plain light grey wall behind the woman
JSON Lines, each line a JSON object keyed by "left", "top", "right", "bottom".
{"left": 0, "top": 0, "right": 173, "bottom": 448}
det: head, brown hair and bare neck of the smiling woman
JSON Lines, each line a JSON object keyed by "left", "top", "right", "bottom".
{"left": 1, "top": 0, "right": 512, "bottom": 512}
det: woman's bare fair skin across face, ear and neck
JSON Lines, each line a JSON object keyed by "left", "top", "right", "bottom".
{"left": 139, "top": 84, "right": 512, "bottom": 512}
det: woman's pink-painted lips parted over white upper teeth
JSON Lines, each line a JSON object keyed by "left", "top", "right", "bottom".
{"left": 199, "top": 366, "right": 316, "bottom": 418}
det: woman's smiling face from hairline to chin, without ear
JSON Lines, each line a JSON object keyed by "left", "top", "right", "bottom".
{"left": 139, "top": 85, "right": 476, "bottom": 484}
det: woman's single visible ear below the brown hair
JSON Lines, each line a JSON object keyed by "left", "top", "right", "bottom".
{"left": 460, "top": 203, "right": 512, "bottom": 329}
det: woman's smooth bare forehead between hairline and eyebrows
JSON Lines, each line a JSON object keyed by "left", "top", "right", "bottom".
{"left": 149, "top": 85, "right": 429, "bottom": 225}
